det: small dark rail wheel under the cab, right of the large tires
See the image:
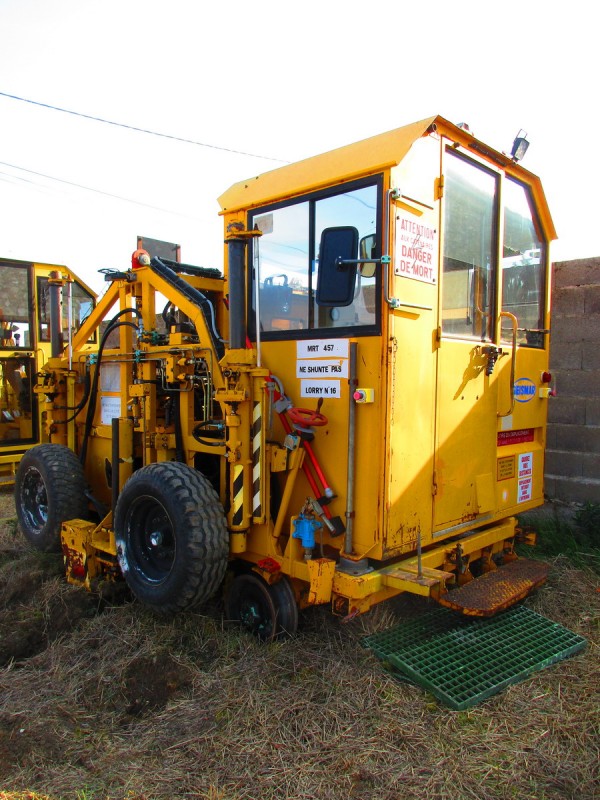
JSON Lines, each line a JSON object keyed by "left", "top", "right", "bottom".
{"left": 225, "top": 572, "right": 277, "bottom": 642}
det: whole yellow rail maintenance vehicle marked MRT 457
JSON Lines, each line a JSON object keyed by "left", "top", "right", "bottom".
{"left": 16, "top": 117, "right": 555, "bottom": 639}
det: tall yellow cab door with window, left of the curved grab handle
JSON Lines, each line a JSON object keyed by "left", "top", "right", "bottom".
{"left": 433, "top": 147, "right": 501, "bottom": 538}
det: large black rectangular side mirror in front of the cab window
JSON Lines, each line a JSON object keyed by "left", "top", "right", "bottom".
{"left": 316, "top": 230, "right": 358, "bottom": 307}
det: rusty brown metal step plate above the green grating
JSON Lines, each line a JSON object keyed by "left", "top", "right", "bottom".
{"left": 438, "top": 558, "right": 550, "bottom": 617}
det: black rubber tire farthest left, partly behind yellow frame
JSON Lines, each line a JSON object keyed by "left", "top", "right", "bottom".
{"left": 15, "top": 444, "right": 88, "bottom": 552}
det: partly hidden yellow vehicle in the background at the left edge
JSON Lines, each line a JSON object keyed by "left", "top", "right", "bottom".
{"left": 0, "top": 258, "right": 96, "bottom": 486}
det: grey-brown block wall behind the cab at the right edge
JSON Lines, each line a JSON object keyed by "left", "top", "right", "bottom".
{"left": 545, "top": 258, "right": 600, "bottom": 503}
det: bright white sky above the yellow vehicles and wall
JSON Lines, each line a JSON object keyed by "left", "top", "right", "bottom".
{"left": 0, "top": 0, "right": 600, "bottom": 290}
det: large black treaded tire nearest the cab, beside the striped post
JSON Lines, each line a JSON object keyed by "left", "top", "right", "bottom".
{"left": 114, "top": 461, "right": 229, "bottom": 615}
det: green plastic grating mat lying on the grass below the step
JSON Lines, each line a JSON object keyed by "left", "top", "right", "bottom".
{"left": 362, "top": 606, "right": 587, "bottom": 711}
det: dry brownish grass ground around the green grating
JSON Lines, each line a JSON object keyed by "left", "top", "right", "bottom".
{"left": 0, "top": 484, "right": 600, "bottom": 800}
